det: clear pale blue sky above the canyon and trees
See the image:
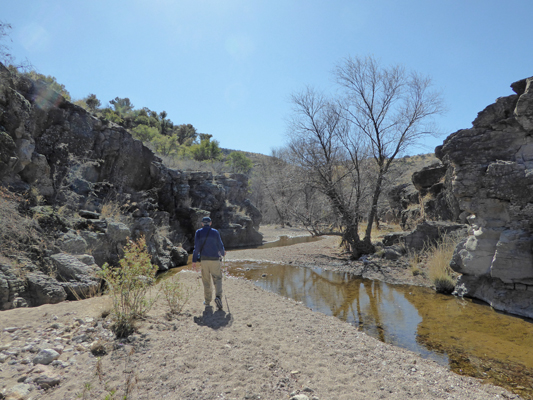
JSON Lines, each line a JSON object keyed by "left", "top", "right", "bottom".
{"left": 0, "top": 0, "right": 533, "bottom": 154}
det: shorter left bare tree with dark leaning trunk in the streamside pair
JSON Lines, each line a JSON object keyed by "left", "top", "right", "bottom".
{"left": 289, "top": 88, "right": 372, "bottom": 258}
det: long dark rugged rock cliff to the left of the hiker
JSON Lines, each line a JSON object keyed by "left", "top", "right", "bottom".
{"left": 0, "top": 64, "right": 262, "bottom": 309}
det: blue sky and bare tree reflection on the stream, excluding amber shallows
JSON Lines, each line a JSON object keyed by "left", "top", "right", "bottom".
{"left": 230, "top": 262, "right": 448, "bottom": 364}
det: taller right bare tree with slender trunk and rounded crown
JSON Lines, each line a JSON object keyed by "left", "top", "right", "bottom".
{"left": 335, "top": 57, "right": 443, "bottom": 244}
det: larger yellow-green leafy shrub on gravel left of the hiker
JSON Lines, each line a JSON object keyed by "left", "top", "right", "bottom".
{"left": 101, "top": 237, "right": 158, "bottom": 337}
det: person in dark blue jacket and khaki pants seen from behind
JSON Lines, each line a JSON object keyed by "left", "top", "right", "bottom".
{"left": 192, "top": 217, "right": 226, "bottom": 310}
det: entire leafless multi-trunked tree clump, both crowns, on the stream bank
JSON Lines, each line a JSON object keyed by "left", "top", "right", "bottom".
{"left": 288, "top": 57, "right": 443, "bottom": 258}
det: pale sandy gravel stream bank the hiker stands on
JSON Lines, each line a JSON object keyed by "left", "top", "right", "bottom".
{"left": 0, "top": 225, "right": 519, "bottom": 400}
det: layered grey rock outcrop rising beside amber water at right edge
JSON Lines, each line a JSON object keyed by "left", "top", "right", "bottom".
{"left": 435, "top": 77, "right": 533, "bottom": 318}
